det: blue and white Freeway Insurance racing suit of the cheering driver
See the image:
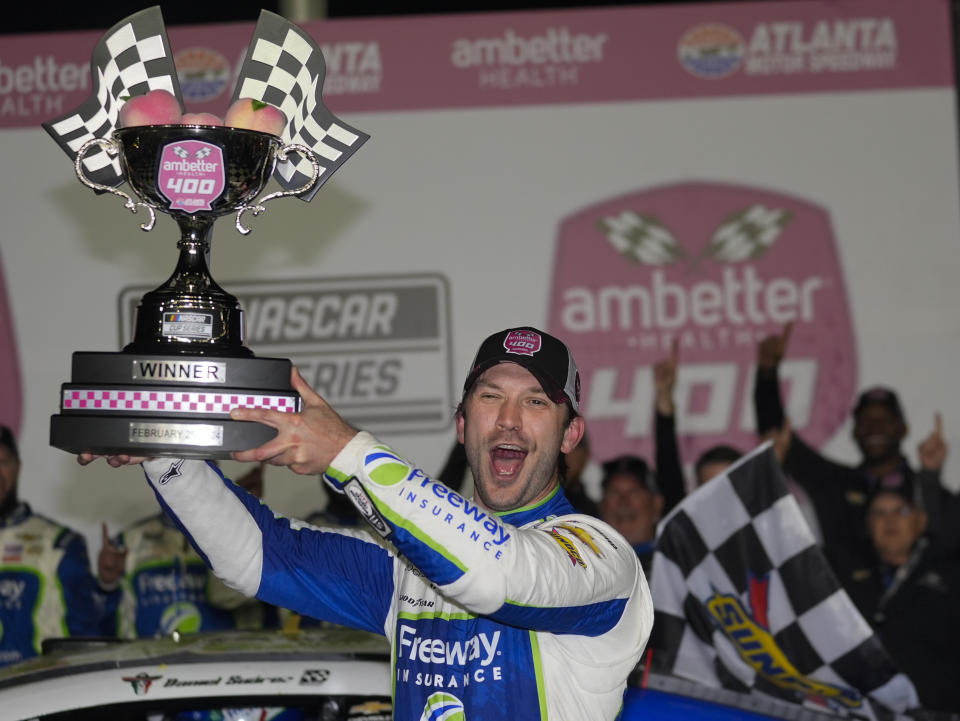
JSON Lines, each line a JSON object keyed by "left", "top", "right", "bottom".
{"left": 143, "top": 432, "right": 653, "bottom": 721}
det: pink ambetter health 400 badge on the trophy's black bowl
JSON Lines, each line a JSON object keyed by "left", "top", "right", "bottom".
{"left": 157, "top": 140, "right": 226, "bottom": 213}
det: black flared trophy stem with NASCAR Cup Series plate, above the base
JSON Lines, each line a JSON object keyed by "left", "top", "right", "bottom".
{"left": 123, "top": 217, "right": 253, "bottom": 357}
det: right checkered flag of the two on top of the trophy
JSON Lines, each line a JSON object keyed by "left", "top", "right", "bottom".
{"left": 233, "top": 10, "right": 370, "bottom": 200}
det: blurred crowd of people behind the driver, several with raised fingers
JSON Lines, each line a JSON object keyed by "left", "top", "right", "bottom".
{"left": 0, "top": 324, "right": 960, "bottom": 712}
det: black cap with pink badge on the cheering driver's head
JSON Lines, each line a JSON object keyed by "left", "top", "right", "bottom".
{"left": 463, "top": 326, "right": 580, "bottom": 413}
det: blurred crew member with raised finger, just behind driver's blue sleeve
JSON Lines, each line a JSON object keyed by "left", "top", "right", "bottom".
{"left": 97, "top": 465, "right": 279, "bottom": 638}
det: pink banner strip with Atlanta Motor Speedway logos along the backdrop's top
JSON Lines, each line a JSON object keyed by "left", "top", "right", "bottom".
{"left": 0, "top": 0, "right": 953, "bottom": 127}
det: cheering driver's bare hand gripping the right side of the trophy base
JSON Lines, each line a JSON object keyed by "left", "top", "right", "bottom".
{"left": 230, "top": 368, "right": 357, "bottom": 475}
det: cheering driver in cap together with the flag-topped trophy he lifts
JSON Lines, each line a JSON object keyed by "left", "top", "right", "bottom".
{"left": 47, "top": 8, "right": 653, "bottom": 721}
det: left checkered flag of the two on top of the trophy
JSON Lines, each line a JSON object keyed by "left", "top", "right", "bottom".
{"left": 43, "top": 6, "right": 183, "bottom": 187}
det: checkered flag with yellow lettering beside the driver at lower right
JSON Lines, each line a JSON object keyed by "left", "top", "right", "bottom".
{"left": 650, "top": 443, "right": 918, "bottom": 718}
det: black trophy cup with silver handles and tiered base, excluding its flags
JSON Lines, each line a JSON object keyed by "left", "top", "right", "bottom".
{"left": 50, "top": 125, "right": 320, "bottom": 458}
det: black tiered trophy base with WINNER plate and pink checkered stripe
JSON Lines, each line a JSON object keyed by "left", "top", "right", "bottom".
{"left": 50, "top": 352, "right": 300, "bottom": 459}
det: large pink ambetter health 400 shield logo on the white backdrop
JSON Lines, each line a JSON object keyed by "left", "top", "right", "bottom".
{"left": 549, "top": 183, "right": 857, "bottom": 461}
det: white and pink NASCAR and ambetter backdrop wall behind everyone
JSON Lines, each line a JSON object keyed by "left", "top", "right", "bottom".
{"left": 0, "top": 0, "right": 960, "bottom": 553}
